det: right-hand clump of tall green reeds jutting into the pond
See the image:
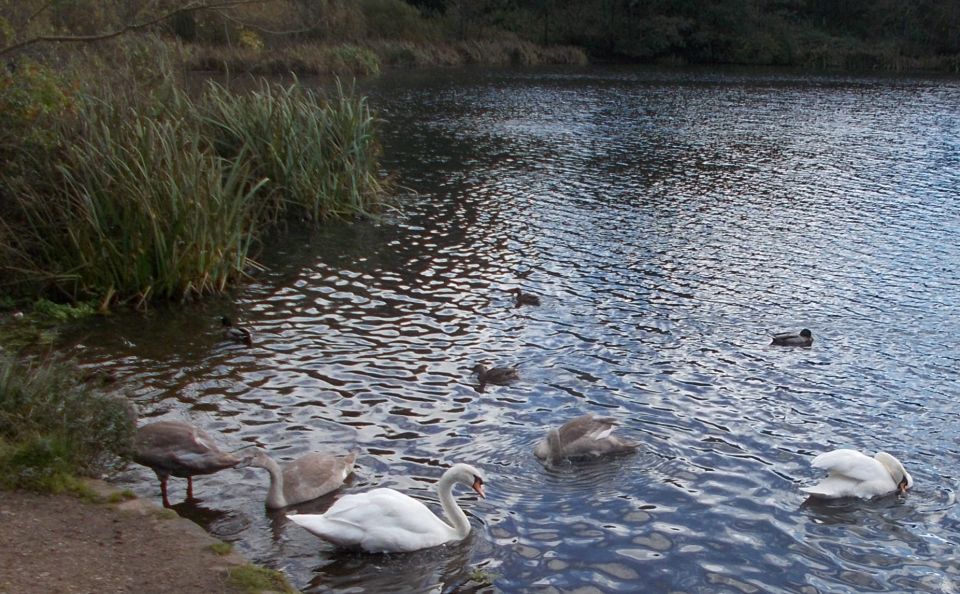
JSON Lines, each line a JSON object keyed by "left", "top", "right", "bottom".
{"left": 203, "top": 81, "right": 385, "bottom": 222}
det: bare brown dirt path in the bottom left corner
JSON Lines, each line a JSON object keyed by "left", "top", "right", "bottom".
{"left": 0, "top": 486, "right": 282, "bottom": 594}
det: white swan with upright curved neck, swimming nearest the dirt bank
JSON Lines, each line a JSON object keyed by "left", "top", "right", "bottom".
{"left": 287, "top": 464, "right": 484, "bottom": 553}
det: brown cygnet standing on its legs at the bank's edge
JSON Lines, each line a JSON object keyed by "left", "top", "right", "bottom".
{"left": 132, "top": 421, "right": 249, "bottom": 507}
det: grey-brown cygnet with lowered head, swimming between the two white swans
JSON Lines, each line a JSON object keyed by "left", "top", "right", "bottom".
{"left": 533, "top": 414, "right": 637, "bottom": 464}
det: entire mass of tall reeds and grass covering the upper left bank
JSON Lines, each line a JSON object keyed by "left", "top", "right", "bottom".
{"left": 0, "top": 37, "right": 385, "bottom": 307}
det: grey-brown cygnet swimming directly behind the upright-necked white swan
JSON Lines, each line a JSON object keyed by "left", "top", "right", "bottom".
{"left": 250, "top": 450, "right": 359, "bottom": 509}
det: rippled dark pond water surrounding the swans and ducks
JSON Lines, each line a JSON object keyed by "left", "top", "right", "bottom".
{"left": 86, "top": 68, "right": 960, "bottom": 593}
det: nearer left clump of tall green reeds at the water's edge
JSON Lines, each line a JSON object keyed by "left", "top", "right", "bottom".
{"left": 6, "top": 99, "right": 264, "bottom": 304}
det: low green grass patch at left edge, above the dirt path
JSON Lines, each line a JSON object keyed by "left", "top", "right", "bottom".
{"left": 0, "top": 357, "right": 133, "bottom": 494}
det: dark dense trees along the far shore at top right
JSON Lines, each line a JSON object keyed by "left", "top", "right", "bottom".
{"left": 408, "top": 0, "right": 960, "bottom": 69}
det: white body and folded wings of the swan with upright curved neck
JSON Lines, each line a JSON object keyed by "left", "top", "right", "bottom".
{"left": 288, "top": 489, "right": 455, "bottom": 552}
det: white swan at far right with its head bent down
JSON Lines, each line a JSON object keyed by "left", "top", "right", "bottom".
{"left": 800, "top": 450, "right": 913, "bottom": 499}
